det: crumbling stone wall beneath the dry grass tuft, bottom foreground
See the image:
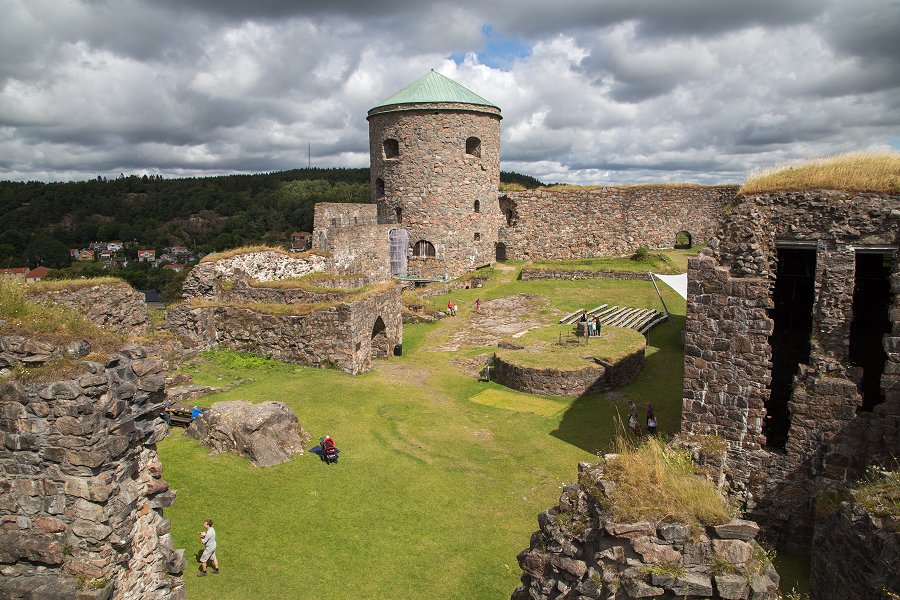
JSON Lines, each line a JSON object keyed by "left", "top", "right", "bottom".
{"left": 512, "top": 463, "right": 778, "bottom": 600}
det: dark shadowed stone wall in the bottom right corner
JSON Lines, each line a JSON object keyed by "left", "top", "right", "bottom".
{"left": 809, "top": 502, "right": 900, "bottom": 600}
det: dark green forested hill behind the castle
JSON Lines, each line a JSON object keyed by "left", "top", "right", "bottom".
{"left": 0, "top": 169, "right": 541, "bottom": 267}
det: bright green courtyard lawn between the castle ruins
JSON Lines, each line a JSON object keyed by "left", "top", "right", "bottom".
{"left": 159, "top": 270, "right": 684, "bottom": 599}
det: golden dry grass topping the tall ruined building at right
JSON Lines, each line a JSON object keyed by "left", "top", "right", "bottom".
{"left": 739, "top": 152, "right": 900, "bottom": 195}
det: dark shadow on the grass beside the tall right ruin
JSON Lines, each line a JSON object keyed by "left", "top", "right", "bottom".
{"left": 550, "top": 315, "right": 684, "bottom": 454}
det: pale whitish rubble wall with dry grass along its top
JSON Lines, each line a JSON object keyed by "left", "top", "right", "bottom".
{"left": 182, "top": 250, "right": 327, "bottom": 300}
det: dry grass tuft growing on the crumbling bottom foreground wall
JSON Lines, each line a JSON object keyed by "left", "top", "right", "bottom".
{"left": 605, "top": 438, "right": 736, "bottom": 525}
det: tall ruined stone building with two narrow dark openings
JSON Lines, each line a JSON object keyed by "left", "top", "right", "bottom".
{"left": 682, "top": 191, "right": 900, "bottom": 547}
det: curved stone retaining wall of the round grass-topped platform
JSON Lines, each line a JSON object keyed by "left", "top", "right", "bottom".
{"left": 493, "top": 348, "right": 644, "bottom": 396}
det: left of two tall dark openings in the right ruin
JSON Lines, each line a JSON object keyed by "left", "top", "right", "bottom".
{"left": 763, "top": 248, "right": 816, "bottom": 449}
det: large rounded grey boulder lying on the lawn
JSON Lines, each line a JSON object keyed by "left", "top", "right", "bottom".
{"left": 187, "top": 400, "right": 310, "bottom": 467}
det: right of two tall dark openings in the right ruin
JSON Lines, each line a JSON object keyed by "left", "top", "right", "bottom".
{"left": 850, "top": 250, "right": 893, "bottom": 412}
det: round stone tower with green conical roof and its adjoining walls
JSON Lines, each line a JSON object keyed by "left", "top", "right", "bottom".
{"left": 313, "top": 71, "right": 737, "bottom": 280}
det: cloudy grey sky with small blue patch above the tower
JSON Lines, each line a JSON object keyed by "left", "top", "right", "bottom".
{"left": 0, "top": 0, "right": 900, "bottom": 183}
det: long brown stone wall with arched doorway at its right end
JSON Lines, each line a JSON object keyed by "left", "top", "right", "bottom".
{"left": 166, "top": 286, "right": 403, "bottom": 374}
